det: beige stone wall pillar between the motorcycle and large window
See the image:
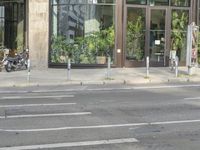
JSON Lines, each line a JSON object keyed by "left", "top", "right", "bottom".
{"left": 28, "top": 0, "right": 49, "bottom": 69}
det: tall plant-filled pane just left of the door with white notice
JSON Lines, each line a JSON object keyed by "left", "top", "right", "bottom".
{"left": 126, "top": 8, "right": 145, "bottom": 61}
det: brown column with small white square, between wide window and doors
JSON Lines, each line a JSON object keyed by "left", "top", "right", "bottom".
{"left": 115, "top": 0, "right": 124, "bottom": 67}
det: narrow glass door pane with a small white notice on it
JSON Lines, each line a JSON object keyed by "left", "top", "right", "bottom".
{"left": 149, "top": 9, "right": 166, "bottom": 66}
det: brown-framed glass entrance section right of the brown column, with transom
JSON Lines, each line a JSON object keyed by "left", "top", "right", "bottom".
{"left": 123, "top": 0, "right": 197, "bottom": 66}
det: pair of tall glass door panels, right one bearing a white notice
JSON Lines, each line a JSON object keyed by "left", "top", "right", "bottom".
{"left": 124, "top": 6, "right": 170, "bottom": 67}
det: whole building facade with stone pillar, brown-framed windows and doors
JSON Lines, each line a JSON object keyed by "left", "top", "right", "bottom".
{"left": 0, "top": 0, "right": 200, "bottom": 68}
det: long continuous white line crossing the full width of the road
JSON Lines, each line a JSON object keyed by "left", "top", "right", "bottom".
{"left": 0, "top": 120, "right": 200, "bottom": 132}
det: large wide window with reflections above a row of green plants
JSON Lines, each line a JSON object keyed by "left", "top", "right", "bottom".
{"left": 50, "top": 4, "right": 115, "bottom": 64}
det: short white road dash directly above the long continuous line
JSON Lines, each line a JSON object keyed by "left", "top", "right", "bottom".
{"left": 0, "top": 112, "right": 92, "bottom": 119}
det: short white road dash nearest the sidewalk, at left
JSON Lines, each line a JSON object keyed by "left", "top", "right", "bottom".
{"left": 0, "top": 95, "right": 74, "bottom": 100}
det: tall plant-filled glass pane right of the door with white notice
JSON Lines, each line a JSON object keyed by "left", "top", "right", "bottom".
{"left": 171, "top": 10, "right": 189, "bottom": 61}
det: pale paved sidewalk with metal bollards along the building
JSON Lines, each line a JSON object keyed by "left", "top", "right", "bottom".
{"left": 0, "top": 67, "right": 200, "bottom": 87}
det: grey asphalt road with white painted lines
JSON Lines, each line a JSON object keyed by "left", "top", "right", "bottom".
{"left": 0, "top": 84, "right": 200, "bottom": 150}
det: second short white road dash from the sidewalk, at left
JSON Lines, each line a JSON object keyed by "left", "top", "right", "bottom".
{"left": 0, "top": 103, "right": 76, "bottom": 108}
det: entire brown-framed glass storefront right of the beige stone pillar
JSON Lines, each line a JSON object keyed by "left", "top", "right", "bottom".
{"left": 49, "top": 0, "right": 197, "bottom": 67}
